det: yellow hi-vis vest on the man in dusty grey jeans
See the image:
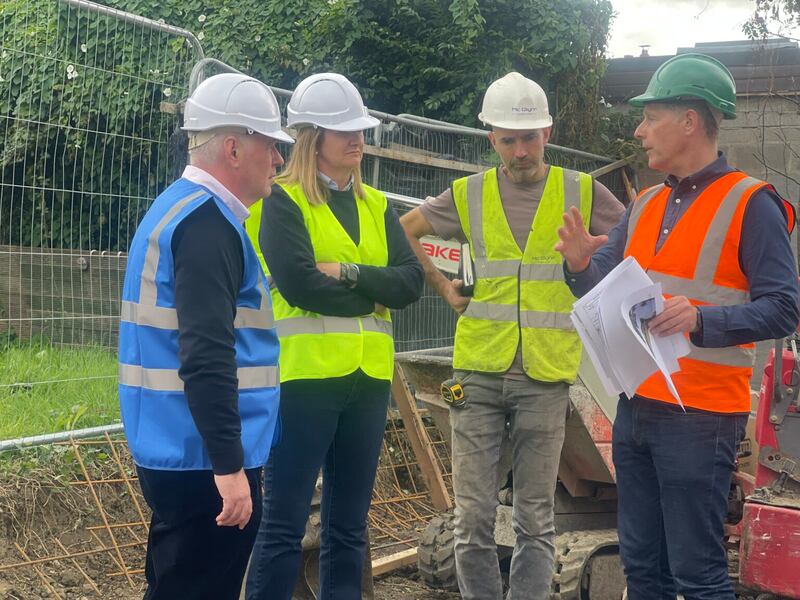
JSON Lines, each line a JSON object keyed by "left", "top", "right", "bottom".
{"left": 453, "top": 166, "right": 592, "bottom": 383}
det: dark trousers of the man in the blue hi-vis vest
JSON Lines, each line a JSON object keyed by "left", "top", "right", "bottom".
{"left": 136, "top": 467, "right": 261, "bottom": 600}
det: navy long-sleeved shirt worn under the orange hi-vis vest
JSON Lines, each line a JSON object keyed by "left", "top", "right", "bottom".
{"left": 564, "top": 153, "right": 800, "bottom": 348}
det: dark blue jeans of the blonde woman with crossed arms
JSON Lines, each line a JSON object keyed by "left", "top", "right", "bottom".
{"left": 247, "top": 370, "right": 390, "bottom": 600}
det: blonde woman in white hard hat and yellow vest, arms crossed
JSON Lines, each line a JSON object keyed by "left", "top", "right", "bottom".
{"left": 246, "top": 73, "right": 423, "bottom": 600}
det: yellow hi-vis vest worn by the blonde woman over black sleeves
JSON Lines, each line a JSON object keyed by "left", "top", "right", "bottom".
{"left": 245, "top": 184, "right": 394, "bottom": 382}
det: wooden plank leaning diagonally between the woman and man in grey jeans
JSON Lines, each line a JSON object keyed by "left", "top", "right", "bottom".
{"left": 392, "top": 362, "right": 453, "bottom": 510}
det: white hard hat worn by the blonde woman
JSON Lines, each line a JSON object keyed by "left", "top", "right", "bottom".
{"left": 286, "top": 73, "right": 380, "bottom": 131}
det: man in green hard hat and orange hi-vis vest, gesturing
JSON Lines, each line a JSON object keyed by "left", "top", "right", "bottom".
{"left": 556, "top": 54, "right": 800, "bottom": 600}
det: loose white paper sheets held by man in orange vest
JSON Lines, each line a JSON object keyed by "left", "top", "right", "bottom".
{"left": 571, "top": 256, "right": 689, "bottom": 407}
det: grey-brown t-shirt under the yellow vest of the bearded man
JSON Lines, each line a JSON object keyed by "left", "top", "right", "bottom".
{"left": 420, "top": 166, "right": 625, "bottom": 380}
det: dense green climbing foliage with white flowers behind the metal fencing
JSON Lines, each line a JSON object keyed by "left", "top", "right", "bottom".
{"left": 0, "top": 0, "right": 612, "bottom": 250}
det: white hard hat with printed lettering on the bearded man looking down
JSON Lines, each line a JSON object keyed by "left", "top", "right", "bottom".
{"left": 478, "top": 71, "right": 553, "bottom": 129}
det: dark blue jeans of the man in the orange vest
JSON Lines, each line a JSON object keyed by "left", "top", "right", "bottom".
{"left": 613, "top": 396, "right": 747, "bottom": 600}
